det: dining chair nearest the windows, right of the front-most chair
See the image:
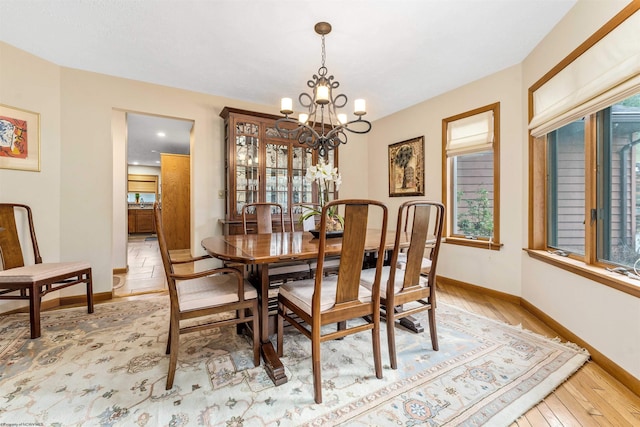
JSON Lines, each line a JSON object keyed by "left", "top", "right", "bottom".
{"left": 362, "top": 200, "right": 445, "bottom": 369}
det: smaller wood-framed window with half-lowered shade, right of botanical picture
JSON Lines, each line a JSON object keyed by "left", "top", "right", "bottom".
{"left": 442, "top": 103, "right": 500, "bottom": 249}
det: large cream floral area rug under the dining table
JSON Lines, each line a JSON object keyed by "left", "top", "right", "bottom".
{"left": 0, "top": 297, "right": 589, "bottom": 427}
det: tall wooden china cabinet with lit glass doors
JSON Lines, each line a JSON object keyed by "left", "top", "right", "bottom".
{"left": 220, "top": 107, "right": 338, "bottom": 234}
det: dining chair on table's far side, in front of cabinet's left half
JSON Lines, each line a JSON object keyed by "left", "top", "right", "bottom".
{"left": 242, "top": 202, "right": 311, "bottom": 283}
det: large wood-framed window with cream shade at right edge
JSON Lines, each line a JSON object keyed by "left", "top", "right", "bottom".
{"left": 529, "top": 2, "right": 640, "bottom": 296}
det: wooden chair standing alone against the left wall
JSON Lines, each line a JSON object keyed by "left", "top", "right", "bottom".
{"left": 0, "top": 203, "right": 93, "bottom": 339}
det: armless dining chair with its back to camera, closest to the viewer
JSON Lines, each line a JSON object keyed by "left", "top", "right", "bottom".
{"left": 277, "top": 199, "right": 387, "bottom": 403}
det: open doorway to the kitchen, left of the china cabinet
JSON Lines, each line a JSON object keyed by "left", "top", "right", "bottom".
{"left": 113, "top": 112, "right": 194, "bottom": 296}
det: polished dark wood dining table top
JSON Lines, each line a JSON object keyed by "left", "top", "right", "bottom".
{"left": 202, "top": 229, "right": 408, "bottom": 264}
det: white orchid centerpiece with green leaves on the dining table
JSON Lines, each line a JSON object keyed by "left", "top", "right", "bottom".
{"left": 300, "top": 159, "right": 344, "bottom": 231}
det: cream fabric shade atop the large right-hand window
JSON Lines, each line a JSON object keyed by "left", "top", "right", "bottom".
{"left": 529, "top": 12, "right": 640, "bottom": 137}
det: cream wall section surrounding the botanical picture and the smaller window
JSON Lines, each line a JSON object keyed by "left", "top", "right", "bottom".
{"left": 369, "top": 65, "right": 526, "bottom": 295}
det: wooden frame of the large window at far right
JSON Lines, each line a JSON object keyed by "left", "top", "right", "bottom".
{"left": 524, "top": 2, "right": 640, "bottom": 298}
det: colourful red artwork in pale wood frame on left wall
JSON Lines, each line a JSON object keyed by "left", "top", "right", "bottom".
{"left": 0, "top": 104, "right": 40, "bottom": 172}
